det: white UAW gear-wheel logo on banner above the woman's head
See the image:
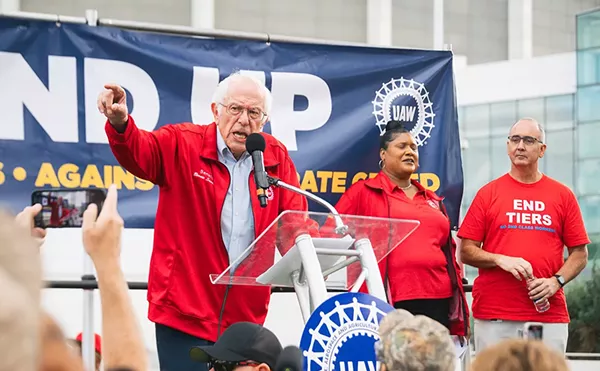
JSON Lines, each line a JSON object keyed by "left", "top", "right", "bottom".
{"left": 372, "top": 77, "right": 435, "bottom": 146}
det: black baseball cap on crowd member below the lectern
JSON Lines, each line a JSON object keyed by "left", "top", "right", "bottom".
{"left": 190, "top": 322, "right": 283, "bottom": 370}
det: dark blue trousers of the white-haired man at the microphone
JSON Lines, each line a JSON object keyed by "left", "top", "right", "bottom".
{"left": 155, "top": 323, "right": 213, "bottom": 371}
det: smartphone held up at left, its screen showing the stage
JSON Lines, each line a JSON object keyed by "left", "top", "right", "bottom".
{"left": 31, "top": 188, "right": 106, "bottom": 229}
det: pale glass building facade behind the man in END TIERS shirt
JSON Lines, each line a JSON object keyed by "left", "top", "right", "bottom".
{"left": 459, "top": 9, "right": 600, "bottom": 353}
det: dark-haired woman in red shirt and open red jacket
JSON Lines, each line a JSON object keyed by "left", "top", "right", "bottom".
{"left": 336, "top": 121, "right": 469, "bottom": 336}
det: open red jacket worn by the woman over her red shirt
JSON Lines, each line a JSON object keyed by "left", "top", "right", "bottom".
{"left": 332, "top": 172, "right": 470, "bottom": 336}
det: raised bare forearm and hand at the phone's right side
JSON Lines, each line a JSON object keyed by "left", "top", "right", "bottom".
{"left": 82, "top": 185, "right": 147, "bottom": 371}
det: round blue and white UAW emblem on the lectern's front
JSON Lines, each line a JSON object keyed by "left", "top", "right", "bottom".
{"left": 300, "top": 292, "right": 394, "bottom": 371}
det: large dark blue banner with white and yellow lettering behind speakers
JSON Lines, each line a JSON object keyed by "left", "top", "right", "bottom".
{"left": 0, "top": 18, "right": 463, "bottom": 228}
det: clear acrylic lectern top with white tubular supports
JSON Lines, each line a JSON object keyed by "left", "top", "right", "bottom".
{"left": 210, "top": 211, "right": 419, "bottom": 322}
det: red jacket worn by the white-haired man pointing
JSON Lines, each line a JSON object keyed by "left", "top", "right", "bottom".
{"left": 105, "top": 116, "right": 308, "bottom": 341}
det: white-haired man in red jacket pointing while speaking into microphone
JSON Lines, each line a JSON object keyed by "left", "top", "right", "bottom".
{"left": 98, "top": 73, "right": 308, "bottom": 371}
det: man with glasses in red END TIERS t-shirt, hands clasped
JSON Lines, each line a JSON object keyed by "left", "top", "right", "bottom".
{"left": 458, "top": 119, "right": 590, "bottom": 353}
